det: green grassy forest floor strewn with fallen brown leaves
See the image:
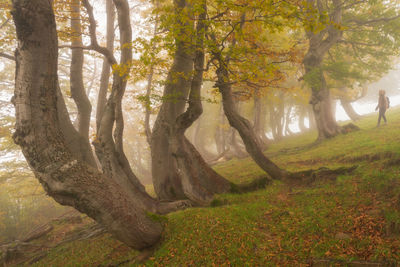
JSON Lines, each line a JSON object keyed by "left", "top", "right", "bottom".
{"left": 3, "top": 108, "right": 400, "bottom": 266}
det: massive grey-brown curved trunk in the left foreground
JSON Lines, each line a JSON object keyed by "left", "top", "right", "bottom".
{"left": 12, "top": 0, "right": 162, "bottom": 249}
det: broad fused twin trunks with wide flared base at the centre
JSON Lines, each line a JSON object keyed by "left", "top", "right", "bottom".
{"left": 151, "top": 0, "right": 229, "bottom": 204}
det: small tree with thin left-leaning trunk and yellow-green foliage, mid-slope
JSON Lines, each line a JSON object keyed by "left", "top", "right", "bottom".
{"left": 208, "top": 1, "right": 302, "bottom": 179}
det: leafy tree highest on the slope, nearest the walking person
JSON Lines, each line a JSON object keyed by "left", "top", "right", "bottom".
{"left": 301, "top": 0, "right": 400, "bottom": 140}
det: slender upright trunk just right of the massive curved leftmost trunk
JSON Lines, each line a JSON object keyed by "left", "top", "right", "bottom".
{"left": 70, "top": 0, "right": 92, "bottom": 138}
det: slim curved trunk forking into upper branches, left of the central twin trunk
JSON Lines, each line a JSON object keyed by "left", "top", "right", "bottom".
{"left": 83, "top": 0, "right": 188, "bottom": 213}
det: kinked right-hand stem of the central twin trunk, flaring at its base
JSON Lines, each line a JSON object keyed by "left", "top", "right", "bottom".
{"left": 172, "top": 0, "right": 230, "bottom": 204}
